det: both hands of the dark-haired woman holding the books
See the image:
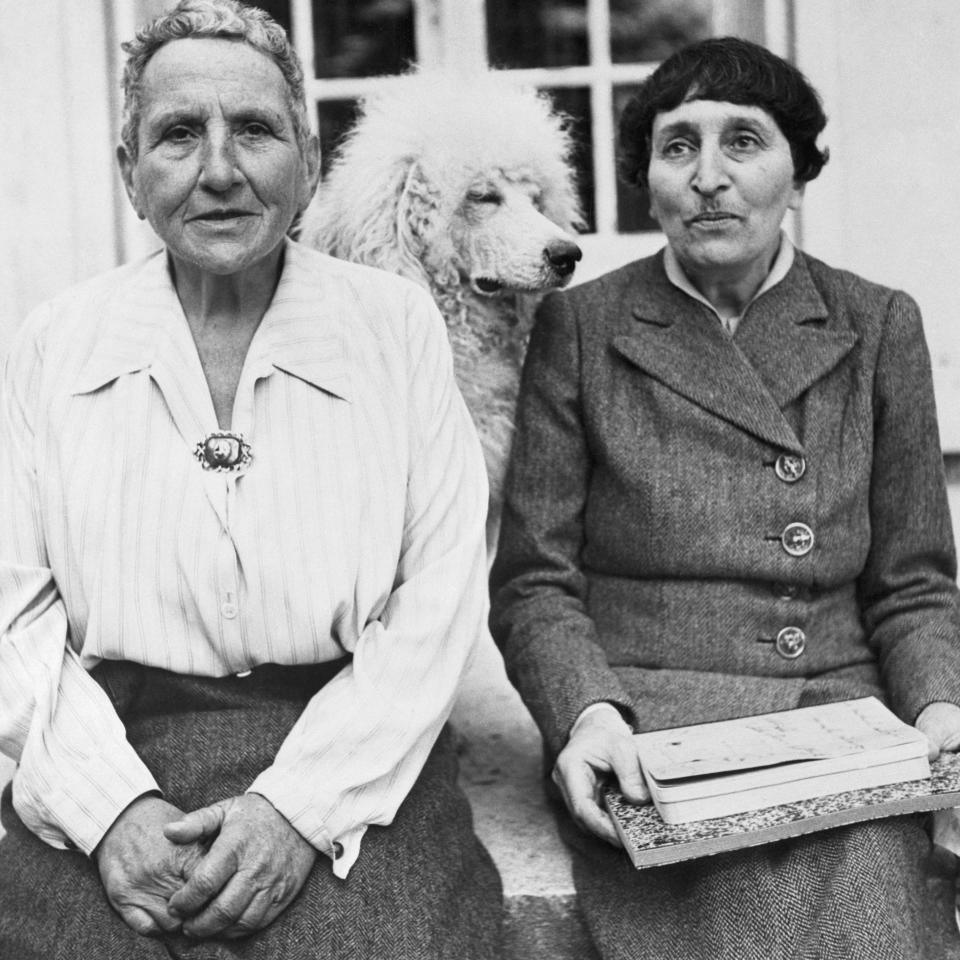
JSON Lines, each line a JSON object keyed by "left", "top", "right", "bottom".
{"left": 553, "top": 702, "right": 960, "bottom": 847}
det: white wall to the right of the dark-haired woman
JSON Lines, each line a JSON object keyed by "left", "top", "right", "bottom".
{"left": 794, "top": 0, "right": 960, "bottom": 453}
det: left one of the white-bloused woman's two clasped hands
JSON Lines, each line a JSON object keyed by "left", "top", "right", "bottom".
{"left": 94, "top": 795, "right": 203, "bottom": 936}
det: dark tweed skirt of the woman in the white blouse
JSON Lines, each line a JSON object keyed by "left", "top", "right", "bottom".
{"left": 0, "top": 663, "right": 502, "bottom": 960}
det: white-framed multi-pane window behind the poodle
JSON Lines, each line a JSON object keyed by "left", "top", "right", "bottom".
{"left": 260, "top": 0, "right": 769, "bottom": 269}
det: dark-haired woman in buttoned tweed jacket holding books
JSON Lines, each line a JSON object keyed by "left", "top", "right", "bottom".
{"left": 491, "top": 38, "right": 960, "bottom": 960}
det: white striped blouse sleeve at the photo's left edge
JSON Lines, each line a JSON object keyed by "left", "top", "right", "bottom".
{"left": 0, "top": 308, "right": 157, "bottom": 853}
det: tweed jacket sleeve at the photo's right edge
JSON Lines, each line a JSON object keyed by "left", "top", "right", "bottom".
{"left": 859, "top": 293, "right": 960, "bottom": 723}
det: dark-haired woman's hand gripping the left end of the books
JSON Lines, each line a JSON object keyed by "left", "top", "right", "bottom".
{"left": 553, "top": 709, "right": 650, "bottom": 847}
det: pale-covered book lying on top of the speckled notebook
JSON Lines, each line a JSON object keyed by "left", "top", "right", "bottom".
{"left": 634, "top": 697, "right": 930, "bottom": 824}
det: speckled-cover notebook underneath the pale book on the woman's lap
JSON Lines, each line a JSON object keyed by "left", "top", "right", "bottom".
{"left": 604, "top": 753, "right": 960, "bottom": 869}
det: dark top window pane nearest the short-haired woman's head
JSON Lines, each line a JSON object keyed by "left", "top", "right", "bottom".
{"left": 313, "top": 0, "right": 416, "bottom": 77}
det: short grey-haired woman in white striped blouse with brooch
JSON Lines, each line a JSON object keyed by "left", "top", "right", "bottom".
{"left": 0, "top": 0, "right": 500, "bottom": 960}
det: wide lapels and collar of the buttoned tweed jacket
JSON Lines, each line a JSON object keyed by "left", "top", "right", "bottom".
{"left": 612, "top": 251, "right": 856, "bottom": 453}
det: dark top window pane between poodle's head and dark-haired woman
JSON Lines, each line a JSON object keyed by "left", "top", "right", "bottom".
{"left": 487, "top": 0, "right": 589, "bottom": 68}
